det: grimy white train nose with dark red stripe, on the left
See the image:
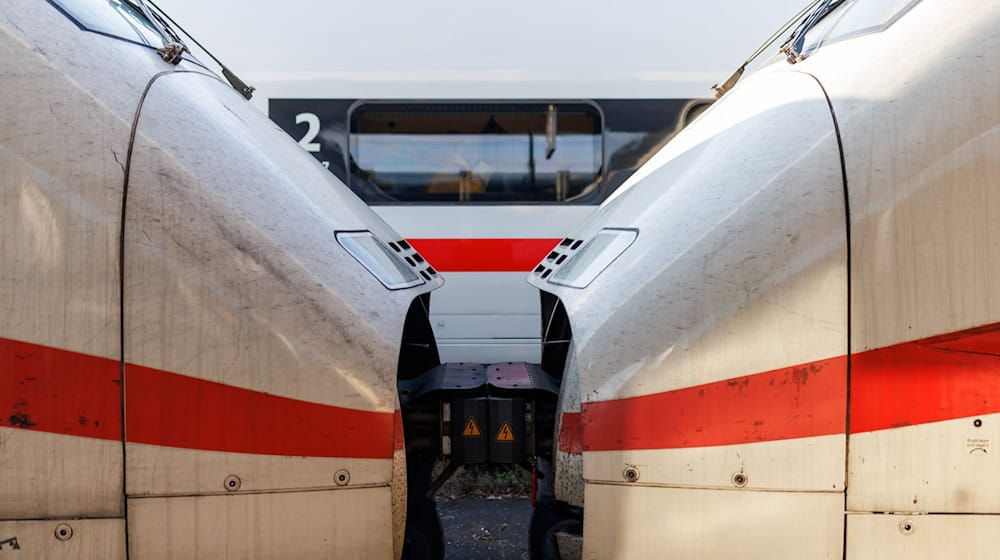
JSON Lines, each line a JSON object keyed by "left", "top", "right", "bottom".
{"left": 0, "top": 0, "right": 441, "bottom": 560}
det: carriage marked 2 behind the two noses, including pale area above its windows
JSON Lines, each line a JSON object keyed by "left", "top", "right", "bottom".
{"left": 163, "top": 0, "right": 803, "bottom": 363}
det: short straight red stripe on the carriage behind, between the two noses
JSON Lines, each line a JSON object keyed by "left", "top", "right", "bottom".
{"left": 407, "top": 239, "right": 560, "bottom": 272}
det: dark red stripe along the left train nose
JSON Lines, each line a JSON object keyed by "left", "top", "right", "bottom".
{"left": 0, "top": 339, "right": 394, "bottom": 459}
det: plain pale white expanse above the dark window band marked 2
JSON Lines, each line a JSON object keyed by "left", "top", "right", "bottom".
{"left": 158, "top": 0, "right": 806, "bottom": 97}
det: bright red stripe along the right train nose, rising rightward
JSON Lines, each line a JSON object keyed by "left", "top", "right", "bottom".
{"left": 584, "top": 325, "right": 1000, "bottom": 451}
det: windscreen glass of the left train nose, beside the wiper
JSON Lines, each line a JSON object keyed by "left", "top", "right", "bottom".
{"left": 52, "top": 0, "right": 162, "bottom": 47}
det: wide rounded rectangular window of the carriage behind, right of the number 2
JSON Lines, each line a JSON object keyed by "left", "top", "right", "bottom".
{"left": 348, "top": 102, "right": 604, "bottom": 204}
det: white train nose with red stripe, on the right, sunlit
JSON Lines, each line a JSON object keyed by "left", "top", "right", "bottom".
{"left": 530, "top": 0, "right": 1000, "bottom": 559}
